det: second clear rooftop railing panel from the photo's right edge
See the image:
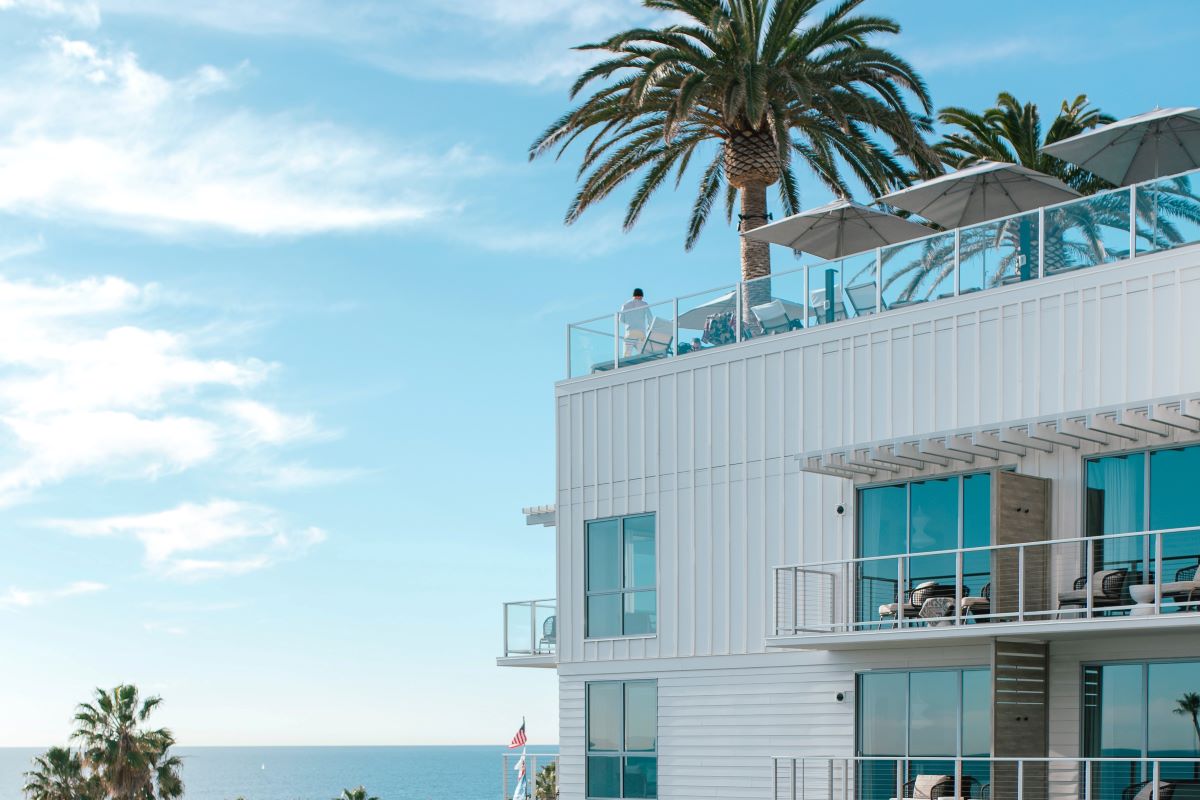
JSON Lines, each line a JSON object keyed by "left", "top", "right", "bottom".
{"left": 1043, "top": 191, "right": 1129, "bottom": 275}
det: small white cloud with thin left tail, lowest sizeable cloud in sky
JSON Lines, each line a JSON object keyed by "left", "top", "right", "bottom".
{"left": 50, "top": 499, "right": 325, "bottom": 579}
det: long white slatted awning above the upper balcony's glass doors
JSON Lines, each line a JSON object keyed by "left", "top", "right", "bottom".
{"left": 793, "top": 397, "right": 1200, "bottom": 480}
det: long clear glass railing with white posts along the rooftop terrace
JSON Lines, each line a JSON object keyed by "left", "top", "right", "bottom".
{"left": 566, "top": 170, "right": 1200, "bottom": 378}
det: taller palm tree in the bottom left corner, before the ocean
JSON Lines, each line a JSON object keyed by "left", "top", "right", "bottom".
{"left": 73, "top": 684, "right": 184, "bottom": 800}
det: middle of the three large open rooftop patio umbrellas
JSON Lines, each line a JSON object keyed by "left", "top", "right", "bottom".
{"left": 878, "top": 161, "right": 1079, "bottom": 228}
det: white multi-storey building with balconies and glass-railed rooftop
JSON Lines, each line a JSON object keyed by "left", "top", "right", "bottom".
{"left": 499, "top": 164, "right": 1200, "bottom": 800}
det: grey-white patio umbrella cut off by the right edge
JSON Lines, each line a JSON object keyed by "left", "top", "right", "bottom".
{"left": 1042, "top": 108, "right": 1200, "bottom": 186}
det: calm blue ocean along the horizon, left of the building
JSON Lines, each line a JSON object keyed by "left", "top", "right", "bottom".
{"left": 0, "top": 746, "right": 558, "bottom": 800}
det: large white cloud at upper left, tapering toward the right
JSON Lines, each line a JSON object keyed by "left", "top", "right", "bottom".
{"left": 0, "top": 36, "right": 488, "bottom": 235}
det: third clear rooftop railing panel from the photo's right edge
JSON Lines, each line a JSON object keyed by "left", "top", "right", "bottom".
{"left": 959, "top": 211, "right": 1038, "bottom": 294}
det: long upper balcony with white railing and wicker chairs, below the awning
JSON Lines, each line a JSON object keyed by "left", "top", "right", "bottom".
{"left": 767, "top": 528, "right": 1200, "bottom": 652}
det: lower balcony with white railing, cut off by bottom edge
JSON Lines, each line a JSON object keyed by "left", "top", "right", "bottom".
{"left": 773, "top": 756, "right": 1200, "bottom": 800}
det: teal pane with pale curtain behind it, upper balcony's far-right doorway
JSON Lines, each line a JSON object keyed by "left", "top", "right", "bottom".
{"left": 1085, "top": 453, "right": 1146, "bottom": 570}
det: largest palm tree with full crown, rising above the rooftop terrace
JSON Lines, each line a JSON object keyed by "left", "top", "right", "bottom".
{"left": 529, "top": 0, "right": 938, "bottom": 293}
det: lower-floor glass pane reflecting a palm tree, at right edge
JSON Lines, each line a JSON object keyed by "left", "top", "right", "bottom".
{"left": 1146, "top": 661, "right": 1200, "bottom": 762}
